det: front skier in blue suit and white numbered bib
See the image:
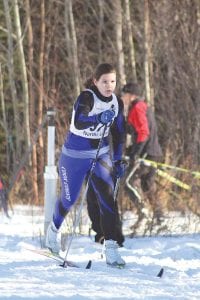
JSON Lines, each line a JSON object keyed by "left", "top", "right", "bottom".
{"left": 46, "top": 63, "right": 125, "bottom": 266}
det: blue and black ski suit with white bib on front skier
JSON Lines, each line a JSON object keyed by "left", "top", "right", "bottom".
{"left": 53, "top": 87, "right": 125, "bottom": 240}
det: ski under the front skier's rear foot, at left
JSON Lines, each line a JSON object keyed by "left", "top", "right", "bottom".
{"left": 26, "top": 248, "right": 92, "bottom": 269}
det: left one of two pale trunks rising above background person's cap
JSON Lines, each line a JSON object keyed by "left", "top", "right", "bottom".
{"left": 113, "top": 0, "right": 126, "bottom": 88}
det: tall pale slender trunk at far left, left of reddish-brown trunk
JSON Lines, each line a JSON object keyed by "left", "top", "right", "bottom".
{"left": 14, "top": 0, "right": 31, "bottom": 152}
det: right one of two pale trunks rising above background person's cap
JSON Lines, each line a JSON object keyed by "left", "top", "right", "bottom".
{"left": 125, "top": 0, "right": 137, "bottom": 82}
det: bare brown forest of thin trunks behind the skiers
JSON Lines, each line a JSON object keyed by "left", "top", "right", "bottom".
{"left": 0, "top": 0, "right": 200, "bottom": 225}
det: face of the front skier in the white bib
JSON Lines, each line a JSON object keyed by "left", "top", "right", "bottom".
{"left": 94, "top": 73, "right": 116, "bottom": 97}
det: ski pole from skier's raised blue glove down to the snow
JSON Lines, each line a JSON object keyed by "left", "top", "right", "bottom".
{"left": 61, "top": 125, "right": 107, "bottom": 268}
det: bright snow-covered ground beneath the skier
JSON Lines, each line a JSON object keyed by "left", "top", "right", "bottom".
{"left": 0, "top": 206, "right": 200, "bottom": 300}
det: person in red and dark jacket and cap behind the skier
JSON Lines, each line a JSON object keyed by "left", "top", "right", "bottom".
{"left": 121, "top": 83, "right": 162, "bottom": 223}
